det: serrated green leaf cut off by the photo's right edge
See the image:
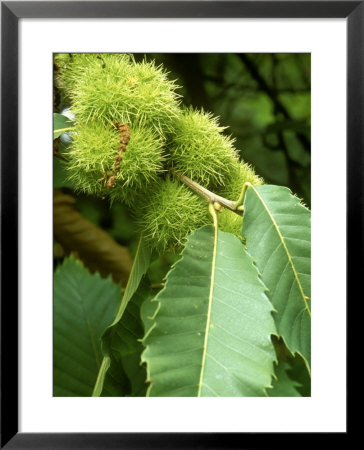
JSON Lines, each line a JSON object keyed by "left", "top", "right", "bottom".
{"left": 243, "top": 185, "right": 311, "bottom": 367}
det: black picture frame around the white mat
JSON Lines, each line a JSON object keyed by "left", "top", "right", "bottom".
{"left": 1, "top": 1, "right": 356, "bottom": 449}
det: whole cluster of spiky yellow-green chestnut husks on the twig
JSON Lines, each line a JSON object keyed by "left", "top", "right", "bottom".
{"left": 54, "top": 53, "right": 263, "bottom": 252}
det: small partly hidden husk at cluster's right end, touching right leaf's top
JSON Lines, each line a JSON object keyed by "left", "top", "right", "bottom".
{"left": 217, "top": 161, "right": 264, "bottom": 200}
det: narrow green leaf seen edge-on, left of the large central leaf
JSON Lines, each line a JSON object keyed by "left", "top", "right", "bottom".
{"left": 92, "top": 237, "right": 151, "bottom": 397}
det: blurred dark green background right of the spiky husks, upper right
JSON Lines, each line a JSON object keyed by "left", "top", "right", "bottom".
{"left": 139, "top": 53, "right": 311, "bottom": 206}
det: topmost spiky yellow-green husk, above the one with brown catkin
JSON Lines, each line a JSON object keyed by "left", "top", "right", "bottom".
{"left": 59, "top": 54, "right": 180, "bottom": 135}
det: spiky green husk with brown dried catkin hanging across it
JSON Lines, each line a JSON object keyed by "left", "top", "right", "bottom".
{"left": 67, "top": 122, "right": 164, "bottom": 202}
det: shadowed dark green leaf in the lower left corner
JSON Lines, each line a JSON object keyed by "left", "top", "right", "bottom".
{"left": 53, "top": 257, "right": 121, "bottom": 397}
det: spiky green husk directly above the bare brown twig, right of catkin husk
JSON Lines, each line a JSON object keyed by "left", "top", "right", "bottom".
{"left": 169, "top": 108, "right": 238, "bottom": 188}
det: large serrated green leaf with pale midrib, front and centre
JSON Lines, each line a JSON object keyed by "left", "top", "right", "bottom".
{"left": 142, "top": 222, "right": 275, "bottom": 396}
